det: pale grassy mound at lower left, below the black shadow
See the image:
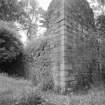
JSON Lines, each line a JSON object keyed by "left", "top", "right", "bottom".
{"left": 0, "top": 75, "right": 40, "bottom": 105}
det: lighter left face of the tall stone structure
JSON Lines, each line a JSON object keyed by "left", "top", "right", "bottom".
{"left": 47, "top": 0, "right": 65, "bottom": 89}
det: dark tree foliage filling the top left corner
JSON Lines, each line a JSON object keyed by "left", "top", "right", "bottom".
{"left": 0, "top": 0, "right": 25, "bottom": 21}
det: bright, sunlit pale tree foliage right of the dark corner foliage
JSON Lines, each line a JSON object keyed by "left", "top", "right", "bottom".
{"left": 19, "top": 0, "right": 40, "bottom": 39}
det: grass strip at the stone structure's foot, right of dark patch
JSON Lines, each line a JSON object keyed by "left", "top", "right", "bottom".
{"left": 41, "top": 86, "right": 105, "bottom": 105}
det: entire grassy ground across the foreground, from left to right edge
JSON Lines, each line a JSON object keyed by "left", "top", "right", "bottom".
{"left": 0, "top": 75, "right": 105, "bottom": 105}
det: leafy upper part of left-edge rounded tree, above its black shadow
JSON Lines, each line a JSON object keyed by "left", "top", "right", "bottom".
{"left": 0, "top": 22, "right": 23, "bottom": 64}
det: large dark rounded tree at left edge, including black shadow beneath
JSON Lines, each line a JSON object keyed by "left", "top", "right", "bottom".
{"left": 0, "top": 21, "right": 26, "bottom": 77}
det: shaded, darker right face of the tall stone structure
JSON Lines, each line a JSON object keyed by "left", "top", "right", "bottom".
{"left": 64, "top": 0, "right": 95, "bottom": 90}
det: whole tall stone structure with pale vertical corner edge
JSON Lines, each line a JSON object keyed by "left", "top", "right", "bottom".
{"left": 45, "top": 0, "right": 94, "bottom": 91}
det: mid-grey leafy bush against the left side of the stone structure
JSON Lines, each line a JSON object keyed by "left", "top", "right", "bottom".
{"left": 26, "top": 38, "right": 54, "bottom": 91}
